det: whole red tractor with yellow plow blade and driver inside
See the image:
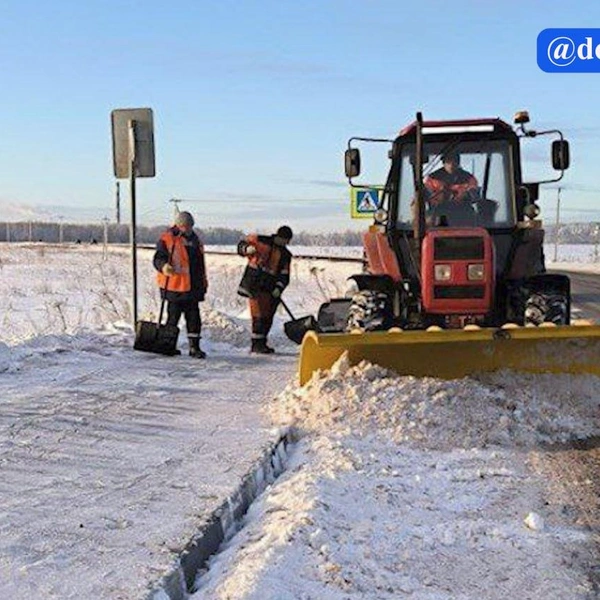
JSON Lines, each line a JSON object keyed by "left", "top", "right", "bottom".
{"left": 300, "top": 112, "right": 600, "bottom": 382}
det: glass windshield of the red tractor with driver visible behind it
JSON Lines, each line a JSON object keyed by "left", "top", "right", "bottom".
{"left": 398, "top": 139, "right": 515, "bottom": 229}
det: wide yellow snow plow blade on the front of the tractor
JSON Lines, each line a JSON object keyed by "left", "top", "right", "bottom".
{"left": 299, "top": 322, "right": 600, "bottom": 385}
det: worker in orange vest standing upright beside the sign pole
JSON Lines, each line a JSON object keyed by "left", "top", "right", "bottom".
{"left": 153, "top": 211, "right": 208, "bottom": 358}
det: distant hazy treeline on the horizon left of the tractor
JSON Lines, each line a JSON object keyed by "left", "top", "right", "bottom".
{"left": 0, "top": 221, "right": 362, "bottom": 246}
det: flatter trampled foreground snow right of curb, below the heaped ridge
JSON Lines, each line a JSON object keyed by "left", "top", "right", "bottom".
{"left": 192, "top": 435, "right": 594, "bottom": 600}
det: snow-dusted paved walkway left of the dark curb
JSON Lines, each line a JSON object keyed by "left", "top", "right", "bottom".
{"left": 0, "top": 335, "right": 295, "bottom": 600}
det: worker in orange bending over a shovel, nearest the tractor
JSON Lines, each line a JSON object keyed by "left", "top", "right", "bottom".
{"left": 238, "top": 225, "right": 292, "bottom": 354}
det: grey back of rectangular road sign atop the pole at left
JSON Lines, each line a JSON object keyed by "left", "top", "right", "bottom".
{"left": 110, "top": 108, "right": 156, "bottom": 179}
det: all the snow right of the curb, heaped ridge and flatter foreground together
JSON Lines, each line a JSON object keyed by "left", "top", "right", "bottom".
{"left": 192, "top": 356, "right": 600, "bottom": 600}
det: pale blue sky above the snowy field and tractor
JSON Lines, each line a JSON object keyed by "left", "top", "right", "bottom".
{"left": 0, "top": 0, "right": 600, "bottom": 231}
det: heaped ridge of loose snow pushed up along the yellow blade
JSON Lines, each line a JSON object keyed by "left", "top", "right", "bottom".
{"left": 269, "top": 355, "right": 600, "bottom": 449}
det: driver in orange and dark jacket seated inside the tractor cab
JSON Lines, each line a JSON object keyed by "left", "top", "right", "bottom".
{"left": 423, "top": 152, "right": 479, "bottom": 221}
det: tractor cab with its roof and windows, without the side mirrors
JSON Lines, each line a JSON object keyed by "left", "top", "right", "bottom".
{"left": 390, "top": 119, "right": 524, "bottom": 291}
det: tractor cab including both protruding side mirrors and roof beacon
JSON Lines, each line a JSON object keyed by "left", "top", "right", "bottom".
{"left": 345, "top": 111, "right": 569, "bottom": 285}
